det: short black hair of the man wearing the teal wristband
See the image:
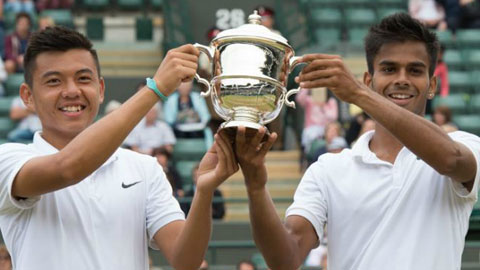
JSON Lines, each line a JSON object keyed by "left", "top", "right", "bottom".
{"left": 23, "top": 26, "right": 100, "bottom": 87}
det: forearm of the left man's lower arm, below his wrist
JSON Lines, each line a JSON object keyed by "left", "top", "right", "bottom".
{"left": 171, "top": 190, "right": 213, "bottom": 270}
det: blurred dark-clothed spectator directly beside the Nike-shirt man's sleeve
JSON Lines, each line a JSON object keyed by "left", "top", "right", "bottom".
{"left": 152, "top": 147, "right": 185, "bottom": 198}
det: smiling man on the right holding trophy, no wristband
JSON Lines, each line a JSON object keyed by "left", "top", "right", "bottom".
{"left": 235, "top": 14, "right": 480, "bottom": 270}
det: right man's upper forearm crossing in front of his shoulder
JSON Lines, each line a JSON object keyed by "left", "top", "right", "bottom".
{"left": 355, "top": 91, "right": 460, "bottom": 173}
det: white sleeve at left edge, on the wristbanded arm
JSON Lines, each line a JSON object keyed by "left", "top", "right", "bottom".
{"left": 0, "top": 143, "right": 40, "bottom": 215}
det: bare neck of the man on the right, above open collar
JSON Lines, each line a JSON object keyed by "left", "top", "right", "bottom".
{"left": 369, "top": 123, "right": 403, "bottom": 164}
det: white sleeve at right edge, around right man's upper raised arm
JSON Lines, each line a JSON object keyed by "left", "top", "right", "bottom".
{"left": 449, "top": 131, "right": 480, "bottom": 201}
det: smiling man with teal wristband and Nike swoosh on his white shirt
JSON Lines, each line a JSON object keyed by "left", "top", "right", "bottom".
{"left": 0, "top": 27, "right": 238, "bottom": 270}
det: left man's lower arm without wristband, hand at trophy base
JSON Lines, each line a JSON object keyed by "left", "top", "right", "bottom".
{"left": 154, "top": 134, "right": 238, "bottom": 270}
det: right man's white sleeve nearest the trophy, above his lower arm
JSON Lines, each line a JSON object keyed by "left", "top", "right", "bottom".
{"left": 285, "top": 161, "right": 328, "bottom": 245}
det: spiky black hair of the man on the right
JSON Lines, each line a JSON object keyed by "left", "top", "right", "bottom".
{"left": 365, "top": 13, "right": 439, "bottom": 76}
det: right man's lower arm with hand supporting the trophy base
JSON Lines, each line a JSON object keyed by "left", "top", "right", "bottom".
{"left": 235, "top": 127, "right": 318, "bottom": 270}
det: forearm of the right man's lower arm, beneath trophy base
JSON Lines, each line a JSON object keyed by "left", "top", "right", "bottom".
{"left": 248, "top": 188, "right": 302, "bottom": 270}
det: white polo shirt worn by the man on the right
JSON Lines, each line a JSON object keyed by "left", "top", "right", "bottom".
{"left": 286, "top": 131, "right": 480, "bottom": 270}
